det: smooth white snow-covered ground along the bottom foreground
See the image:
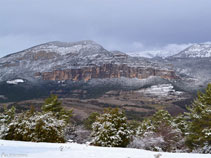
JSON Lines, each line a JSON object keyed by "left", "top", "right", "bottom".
{"left": 0, "top": 140, "right": 211, "bottom": 158}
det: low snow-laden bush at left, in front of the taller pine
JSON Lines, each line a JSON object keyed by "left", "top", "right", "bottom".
{"left": 5, "top": 112, "right": 66, "bottom": 143}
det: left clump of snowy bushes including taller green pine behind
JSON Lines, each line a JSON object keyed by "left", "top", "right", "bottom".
{"left": 0, "top": 95, "right": 72, "bottom": 143}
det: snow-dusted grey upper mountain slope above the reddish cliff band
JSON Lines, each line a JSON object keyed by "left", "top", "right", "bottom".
{"left": 0, "top": 41, "right": 166, "bottom": 81}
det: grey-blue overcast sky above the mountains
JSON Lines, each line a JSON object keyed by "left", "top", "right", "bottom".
{"left": 0, "top": 0, "right": 211, "bottom": 56}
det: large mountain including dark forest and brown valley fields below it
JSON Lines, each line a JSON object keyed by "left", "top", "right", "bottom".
{"left": 0, "top": 41, "right": 203, "bottom": 119}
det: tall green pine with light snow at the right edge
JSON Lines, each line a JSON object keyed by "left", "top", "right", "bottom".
{"left": 186, "top": 100, "right": 211, "bottom": 153}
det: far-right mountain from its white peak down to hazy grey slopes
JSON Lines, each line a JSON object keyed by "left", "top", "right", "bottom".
{"left": 163, "top": 44, "right": 211, "bottom": 90}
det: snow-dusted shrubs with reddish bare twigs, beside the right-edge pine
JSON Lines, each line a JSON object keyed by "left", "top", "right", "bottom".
{"left": 129, "top": 110, "right": 184, "bottom": 152}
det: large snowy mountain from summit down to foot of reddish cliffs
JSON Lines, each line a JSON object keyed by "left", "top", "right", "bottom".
{"left": 0, "top": 41, "right": 175, "bottom": 81}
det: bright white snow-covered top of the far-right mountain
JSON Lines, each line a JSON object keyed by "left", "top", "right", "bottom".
{"left": 172, "top": 44, "right": 211, "bottom": 58}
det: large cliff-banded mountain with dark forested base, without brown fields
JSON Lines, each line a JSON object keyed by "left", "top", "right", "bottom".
{"left": 0, "top": 41, "right": 179, "bottom": 102}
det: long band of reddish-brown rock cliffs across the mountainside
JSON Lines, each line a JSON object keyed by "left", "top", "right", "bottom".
{"left": 36, "top": 64, "right": 178, "bottom": 81}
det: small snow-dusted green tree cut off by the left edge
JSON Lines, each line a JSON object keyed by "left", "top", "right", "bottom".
{"left": 0, "top": 107, "right": 15, "bottom": 139}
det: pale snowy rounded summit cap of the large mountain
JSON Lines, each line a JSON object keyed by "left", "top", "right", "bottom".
{"left": 4, "top": 40, "right": 108, "bottom": 58}
